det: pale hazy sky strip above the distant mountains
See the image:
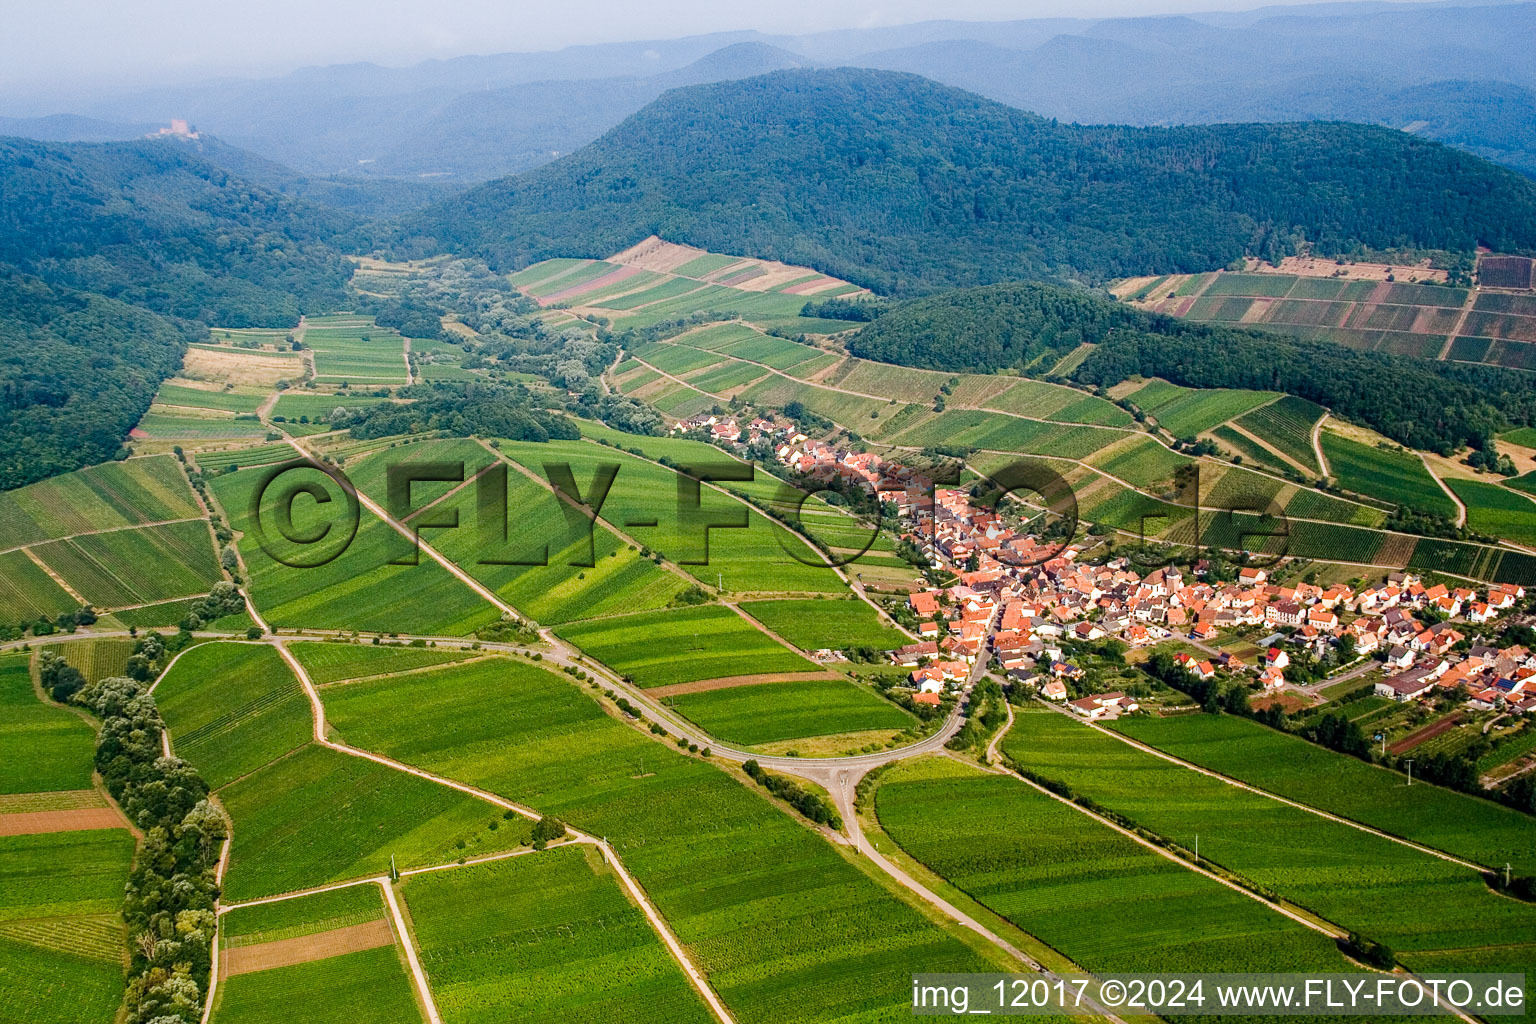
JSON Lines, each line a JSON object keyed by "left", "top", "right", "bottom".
{"left": 0, "top": 0, "right": 1425, "bottom": 94}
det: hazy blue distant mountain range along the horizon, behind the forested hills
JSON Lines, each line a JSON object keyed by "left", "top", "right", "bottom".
{"left": 9, "top": 3, "right": 1536, "bottom": 184}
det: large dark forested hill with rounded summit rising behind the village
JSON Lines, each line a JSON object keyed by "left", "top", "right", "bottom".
{"left": 393, "top": 68, "right": 1536, "bottom": 293}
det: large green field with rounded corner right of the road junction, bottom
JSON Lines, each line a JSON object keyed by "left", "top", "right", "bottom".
{"left": 876, "top": 761, "right": 1349, "bottom": 973}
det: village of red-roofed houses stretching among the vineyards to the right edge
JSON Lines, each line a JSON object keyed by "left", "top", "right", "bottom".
{"left": 673, "top": 415, "right": 1536, "bottom": 720}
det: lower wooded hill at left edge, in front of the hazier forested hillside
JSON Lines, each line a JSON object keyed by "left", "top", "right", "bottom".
{"left": 0, "top": 272, "right": 186, "bottom": 490}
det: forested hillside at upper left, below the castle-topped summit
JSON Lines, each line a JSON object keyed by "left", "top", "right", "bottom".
{"left": 0, "top": 138, "right": 355, "bottom": 327}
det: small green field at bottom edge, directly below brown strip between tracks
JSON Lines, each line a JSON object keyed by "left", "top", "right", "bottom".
{"left": 212, "top": 947, "right": 422, "bottom": 1024}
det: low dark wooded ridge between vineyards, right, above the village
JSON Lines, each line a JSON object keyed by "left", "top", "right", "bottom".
{"left": 848, "top": 282, "right": 1536, "bottom": 454}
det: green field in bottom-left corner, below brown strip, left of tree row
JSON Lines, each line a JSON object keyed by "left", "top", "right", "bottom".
{"left": 0, "top": 829, "right": 134, "bottom": 1024}
